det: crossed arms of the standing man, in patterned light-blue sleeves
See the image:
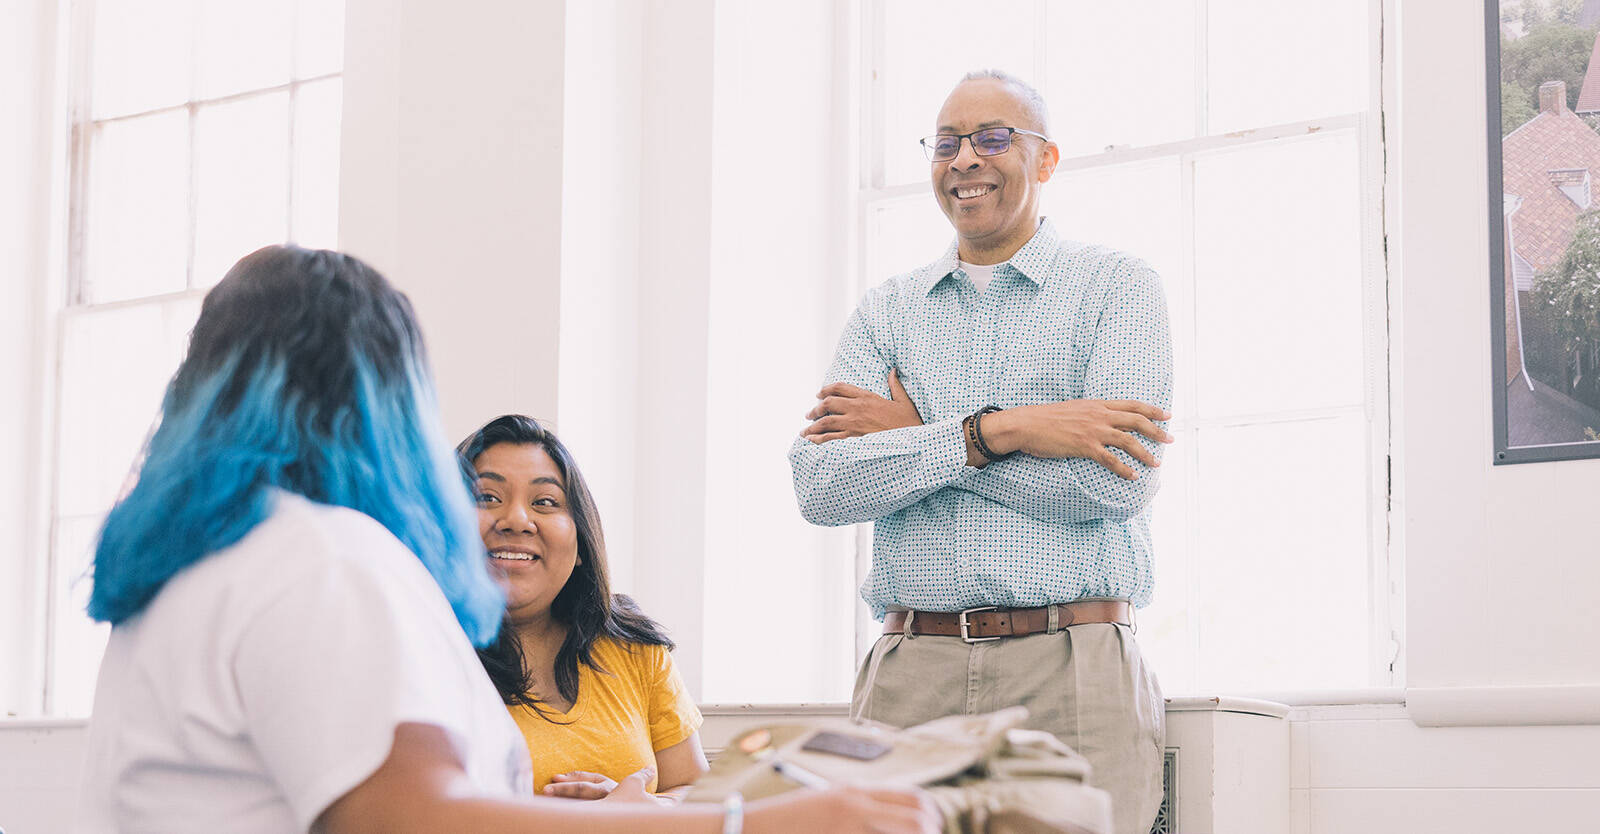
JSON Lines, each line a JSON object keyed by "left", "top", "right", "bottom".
{"left": 789, "top": 267, "right": 1171, "bottom": 525}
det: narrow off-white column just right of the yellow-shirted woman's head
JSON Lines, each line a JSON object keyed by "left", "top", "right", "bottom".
{"left": 620, "top": 0, "right": 726, "bottom": 698}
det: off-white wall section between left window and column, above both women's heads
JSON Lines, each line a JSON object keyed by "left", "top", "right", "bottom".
{"left": 339, "top": 0, "right": 566, "bottom": 440}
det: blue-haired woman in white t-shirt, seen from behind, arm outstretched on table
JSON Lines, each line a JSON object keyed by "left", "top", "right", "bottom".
{"left": 78, "top": 247, "right": 939, "bottom": 834}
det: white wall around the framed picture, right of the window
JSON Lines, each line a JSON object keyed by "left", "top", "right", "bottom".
{"left": 1386, "top": 0, "right": 1600, "bottom": 704}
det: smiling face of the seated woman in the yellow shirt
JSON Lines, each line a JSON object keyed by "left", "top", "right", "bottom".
{"left": 472, "top": 443, "right": 578, "bottom": 621}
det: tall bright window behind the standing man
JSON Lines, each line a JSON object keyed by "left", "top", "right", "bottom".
{"left": 859, "top": 0, "right": 1392, "bottom": 692}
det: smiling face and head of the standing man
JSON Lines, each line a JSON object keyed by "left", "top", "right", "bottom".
{"left": 933, "top": 78, "right": 1059, "bottom": 264}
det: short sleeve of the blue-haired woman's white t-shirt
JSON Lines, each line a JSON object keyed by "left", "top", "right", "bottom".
{"left": 232, "top": 541, "right": 472, "bottom": 829}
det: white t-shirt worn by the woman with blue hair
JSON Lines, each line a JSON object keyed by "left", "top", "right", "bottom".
{"left": 77, "top": 491, "right": 533, "bottom": 834}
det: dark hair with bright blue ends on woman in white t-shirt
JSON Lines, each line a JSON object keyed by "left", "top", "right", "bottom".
{"left": 90, "top": 247, "right": 506, "bottom": 645}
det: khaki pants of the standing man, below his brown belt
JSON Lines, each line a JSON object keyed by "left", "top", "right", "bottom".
{"left": 850, "top": 623, "right": 1166, "bottom": 834}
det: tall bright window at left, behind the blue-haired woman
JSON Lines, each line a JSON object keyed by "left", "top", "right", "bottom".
{"left": 45, "top": 0, "right": 344, "bottom": 716}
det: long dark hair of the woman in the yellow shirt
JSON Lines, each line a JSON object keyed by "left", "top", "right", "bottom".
{"left": 456, "top": 415, "right": 674, "bottom": 720}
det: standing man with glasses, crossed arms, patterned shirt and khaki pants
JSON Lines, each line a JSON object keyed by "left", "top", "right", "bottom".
{"left": 789, "top": 70, "right": 1173, "bottom": 834}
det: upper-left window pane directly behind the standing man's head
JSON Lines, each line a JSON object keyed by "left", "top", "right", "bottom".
{"left": 882, "top": 0, "right": 1038, "bottom": 186}
